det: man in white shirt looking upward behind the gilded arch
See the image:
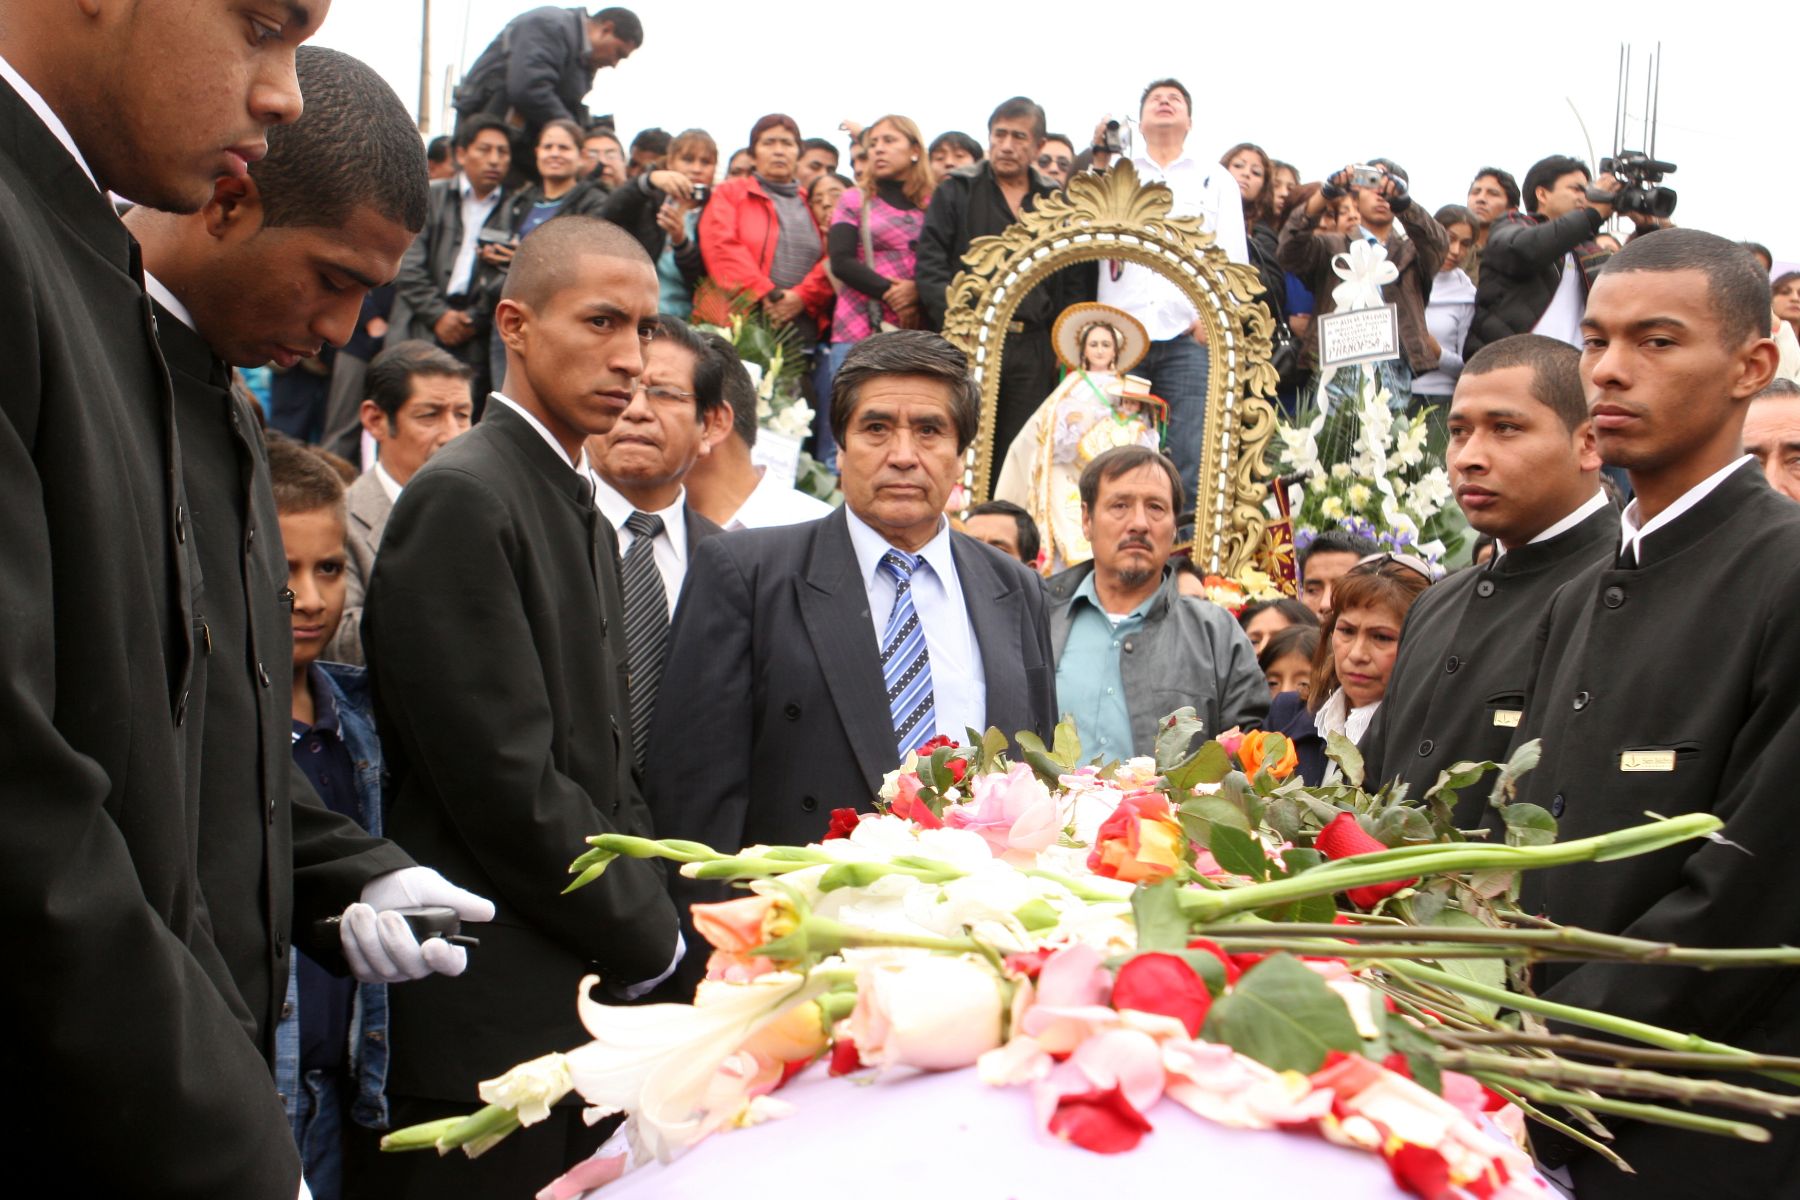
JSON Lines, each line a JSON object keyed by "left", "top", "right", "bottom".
{"left": 1100, "top": 79, "right": 1249, "bottom": 510}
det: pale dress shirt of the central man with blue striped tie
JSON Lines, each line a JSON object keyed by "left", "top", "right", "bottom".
{"left": 844, "top": 507, "right": 988, "bottom": 741}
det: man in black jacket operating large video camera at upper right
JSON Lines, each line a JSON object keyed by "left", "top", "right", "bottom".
{"left": 1463, "top": 155, "right": 1672, "bottom": 360}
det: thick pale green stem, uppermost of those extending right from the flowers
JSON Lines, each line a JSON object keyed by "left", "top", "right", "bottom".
{"left": 1179, "top": 813, "right": 1724, "bottom": 921}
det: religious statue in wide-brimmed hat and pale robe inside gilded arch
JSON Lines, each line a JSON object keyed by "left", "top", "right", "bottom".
{"left": 994, "top": 304, "right": 1163, "bottom": 576}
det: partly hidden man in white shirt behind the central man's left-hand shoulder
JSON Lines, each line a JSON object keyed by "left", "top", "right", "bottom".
{"left": 686, "top": 333, "right": 832, "bottom": 531}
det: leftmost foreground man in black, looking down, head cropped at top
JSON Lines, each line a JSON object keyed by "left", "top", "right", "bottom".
{"left": 0, "top": 0, "right": 343, "bottom": 1200}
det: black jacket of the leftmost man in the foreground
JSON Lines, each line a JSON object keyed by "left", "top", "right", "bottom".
{"left": 0, "top": 85, "right": 299, "bottom": 1200}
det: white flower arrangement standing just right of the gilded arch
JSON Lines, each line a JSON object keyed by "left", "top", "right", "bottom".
{"left": 1276, "top": 369, "right": 1456, "bottom": 560}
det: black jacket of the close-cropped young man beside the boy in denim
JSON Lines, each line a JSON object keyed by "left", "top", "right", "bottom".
{"left": 362, "top": 403, "right": 677, "bottom": 1101}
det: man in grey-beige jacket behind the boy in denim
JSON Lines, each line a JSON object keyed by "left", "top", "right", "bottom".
{"left": 324, "top": 338, "right": 475, "bottom": 664}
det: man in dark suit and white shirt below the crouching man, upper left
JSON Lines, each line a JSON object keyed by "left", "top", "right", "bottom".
{"left": 392, "top": 117, "right": 513, "bottom": 413}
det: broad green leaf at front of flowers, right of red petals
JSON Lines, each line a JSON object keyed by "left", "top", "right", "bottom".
{"left": 1202, "top": 954, "right": 1363, "bottom": 1074}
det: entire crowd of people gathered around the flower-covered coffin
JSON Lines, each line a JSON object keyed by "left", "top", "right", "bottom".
{"left": 0, "top": 0, "right": 1800, "bottom": 1200}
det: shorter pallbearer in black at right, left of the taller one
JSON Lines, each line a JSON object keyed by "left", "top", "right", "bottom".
{"left": 1361, "top": 333, "right": 1618, "bottom": 829}
